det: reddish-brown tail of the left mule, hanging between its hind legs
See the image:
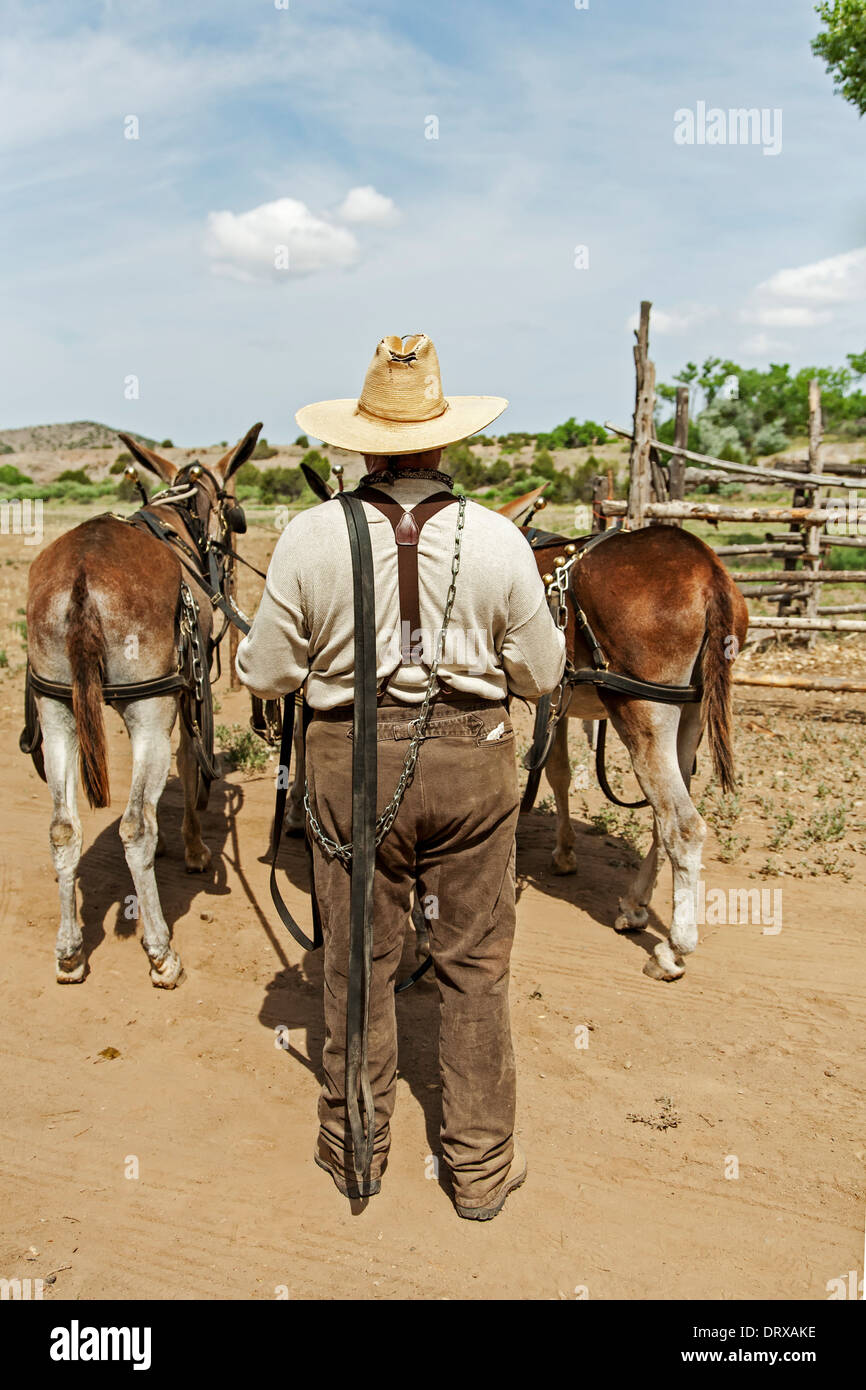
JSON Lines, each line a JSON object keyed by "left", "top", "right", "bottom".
{"left": 67, "top": 569, "right": 108, "bottom": 806}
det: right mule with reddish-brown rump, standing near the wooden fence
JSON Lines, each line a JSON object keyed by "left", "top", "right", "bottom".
{"left": 535, "top": 525, "right": 748, "bottom": 980}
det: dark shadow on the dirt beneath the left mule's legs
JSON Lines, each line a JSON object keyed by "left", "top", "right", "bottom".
{"left": 78, "top": 777, "right": 233, "bottom": 962}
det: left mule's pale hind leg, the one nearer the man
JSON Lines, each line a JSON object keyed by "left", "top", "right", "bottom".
{"left": 121, "top": 695, "right": 183, "bottom": 990}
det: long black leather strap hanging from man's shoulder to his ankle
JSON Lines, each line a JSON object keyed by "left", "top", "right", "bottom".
{"left": 338, "top": 492, "right": 378, "bottom": 1195}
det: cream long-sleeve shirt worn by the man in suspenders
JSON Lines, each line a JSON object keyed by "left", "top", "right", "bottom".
{"left": 236, "top": 478, "right": 566, "bottom": 709}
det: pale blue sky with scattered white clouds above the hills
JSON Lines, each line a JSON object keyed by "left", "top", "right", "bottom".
{"left": 0, "top": 0, "right": 866, "bottom": 445}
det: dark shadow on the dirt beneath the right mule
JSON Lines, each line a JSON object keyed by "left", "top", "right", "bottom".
{"left": 517, "top": 810, "right": 670, "bottom": 956}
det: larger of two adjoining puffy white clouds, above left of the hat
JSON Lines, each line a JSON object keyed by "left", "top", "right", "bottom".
{"left": 204, "top": 197, "right": 360, "bottom": 281}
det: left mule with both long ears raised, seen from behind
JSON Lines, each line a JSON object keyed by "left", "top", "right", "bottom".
{"left": 26, "top": 424, "right": 261, "bottom": 988}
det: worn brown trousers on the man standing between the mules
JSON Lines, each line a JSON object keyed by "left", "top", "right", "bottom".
{"left": 307, "top": 698, "right": 518, "bottom": 1207}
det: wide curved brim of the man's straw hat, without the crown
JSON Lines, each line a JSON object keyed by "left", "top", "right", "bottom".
{"left": 295, "top": 396, "right": 507, "bottom": 453}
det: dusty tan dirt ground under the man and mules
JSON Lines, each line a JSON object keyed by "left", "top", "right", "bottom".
{"left": 0, "top": 518, "right": 866, "bottom": 1300}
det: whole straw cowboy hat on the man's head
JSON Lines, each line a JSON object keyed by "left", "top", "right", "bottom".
{"left": 295, "top": 334, "right": 507, "bottom": 453}
